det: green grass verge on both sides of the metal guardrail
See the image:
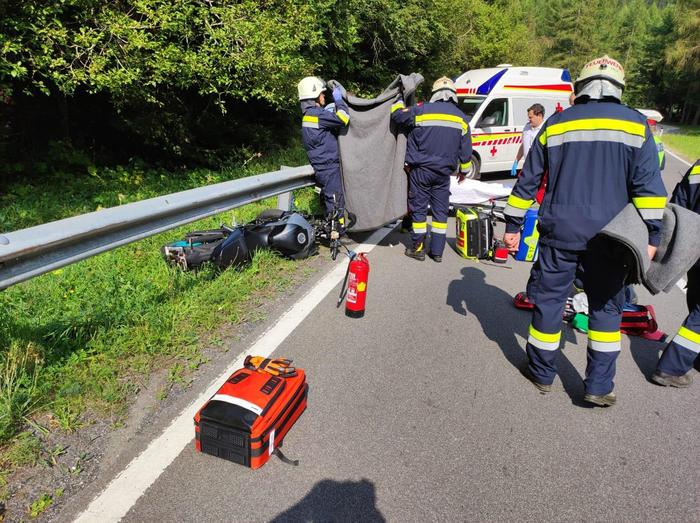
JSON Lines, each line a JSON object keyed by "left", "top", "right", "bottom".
{"left": 0, "top": 142, "right": 317, "bottom": 466}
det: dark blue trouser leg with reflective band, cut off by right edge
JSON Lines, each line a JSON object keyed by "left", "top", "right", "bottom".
{"left": 657, "top": 265, "right": 700, "bottom": 376}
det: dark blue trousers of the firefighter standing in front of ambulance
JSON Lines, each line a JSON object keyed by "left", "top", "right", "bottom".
{"left": 408, "top": 167, "right": 450, "bottom": 256}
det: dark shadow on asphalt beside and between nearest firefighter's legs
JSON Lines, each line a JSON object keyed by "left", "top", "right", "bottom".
{"left": 447, "top": 266, "right": 591, "bottom": 408}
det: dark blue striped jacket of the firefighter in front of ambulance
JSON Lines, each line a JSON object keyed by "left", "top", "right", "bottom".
{"left": 391, "top": 100, "right": 472, "bottom": 176}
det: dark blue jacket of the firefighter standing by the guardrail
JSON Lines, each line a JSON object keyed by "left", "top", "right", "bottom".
{"left": 301, "top": 101, "right": 350, "bottom": 169}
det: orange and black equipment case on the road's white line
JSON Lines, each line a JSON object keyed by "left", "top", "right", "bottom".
{"left": 194, "top": 368, "right": 309, "bottom": 469}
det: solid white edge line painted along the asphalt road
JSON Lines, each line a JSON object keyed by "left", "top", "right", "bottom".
{"left": 75, "top": 227, "right": 393, "bottom": 523}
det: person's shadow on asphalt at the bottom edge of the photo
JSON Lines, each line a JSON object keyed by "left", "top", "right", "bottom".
{"left": 271, "top": 479, "right": 386, "bottom": 523}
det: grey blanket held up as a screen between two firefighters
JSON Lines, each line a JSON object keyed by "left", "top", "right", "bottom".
{"left": 328, "top": 73, "right": 423, "bottom": 231}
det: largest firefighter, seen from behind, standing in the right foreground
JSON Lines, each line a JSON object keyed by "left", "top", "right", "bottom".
{"left": 503, "top": 55, "right": 666, "bottom": 406}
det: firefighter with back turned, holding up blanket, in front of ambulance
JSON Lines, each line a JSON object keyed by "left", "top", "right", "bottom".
{"left": 391, "top": 76, "right": 472, "bottom": 263}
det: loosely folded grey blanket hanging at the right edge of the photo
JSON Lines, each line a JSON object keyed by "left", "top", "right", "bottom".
{"left": 598, "top": 203, "right": 700, "bottom": 294}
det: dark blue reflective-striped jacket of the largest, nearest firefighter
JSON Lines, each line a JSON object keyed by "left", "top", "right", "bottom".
{"left": 505, "top": 102, "right": 666, "bottom": 250}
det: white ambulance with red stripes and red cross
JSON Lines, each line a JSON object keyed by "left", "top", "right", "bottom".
{"left": 455, "top": 64, "right": 574, "bottom": 179}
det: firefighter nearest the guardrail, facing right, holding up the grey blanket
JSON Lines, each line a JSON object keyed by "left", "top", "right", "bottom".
{"left": 297, "top": 76, "right": 350, "bottom": 231}
